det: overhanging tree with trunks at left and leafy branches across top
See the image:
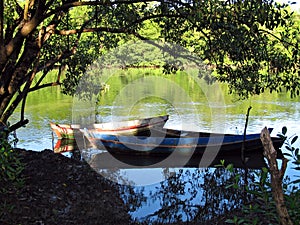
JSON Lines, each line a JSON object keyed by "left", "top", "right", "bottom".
{"left": 0, "top": 0, "right": 299, "bottom": 128}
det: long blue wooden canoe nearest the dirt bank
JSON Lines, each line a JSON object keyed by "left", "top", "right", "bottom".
{"left": 86, "top": 129, "right": 283, "bottom": 155}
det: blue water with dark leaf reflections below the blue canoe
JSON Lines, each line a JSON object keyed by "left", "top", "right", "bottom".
{"left": 81, "top": 149, "right": 262, "bottom": 224}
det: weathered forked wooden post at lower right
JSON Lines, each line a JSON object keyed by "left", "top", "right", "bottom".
{"left": 260, "top": 127, "right": 293, "bottom": 225}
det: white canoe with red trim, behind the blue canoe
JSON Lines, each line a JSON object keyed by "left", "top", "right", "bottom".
{"left": 50, "top": 115, "right": 169, "bottom": 139}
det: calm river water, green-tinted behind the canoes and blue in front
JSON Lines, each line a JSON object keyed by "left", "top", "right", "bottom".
{"left": 11, "top": 72, "right": 300, "bottom": 222}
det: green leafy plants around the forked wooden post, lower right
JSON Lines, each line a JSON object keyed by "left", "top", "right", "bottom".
{"left": 221, "top": 127, "right": 300, "bottom": 225}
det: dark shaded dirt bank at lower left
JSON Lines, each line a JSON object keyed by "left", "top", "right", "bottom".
{"left": 0, "top": 149, "right": 131, "bottom": 225}
